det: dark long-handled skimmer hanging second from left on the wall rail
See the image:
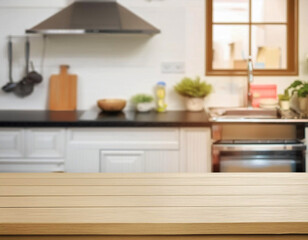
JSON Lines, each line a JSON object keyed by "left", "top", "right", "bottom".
{"left": 14, "top": 38, "right": 34, "bottom": 97}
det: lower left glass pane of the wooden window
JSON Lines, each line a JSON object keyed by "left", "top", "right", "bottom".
{"left": 213, "top": 25, "right": 249, "bottom": 69}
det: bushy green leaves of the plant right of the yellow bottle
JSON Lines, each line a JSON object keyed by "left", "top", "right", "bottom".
{"left": 174, "top": 77, "right": 213, "bottom": 98}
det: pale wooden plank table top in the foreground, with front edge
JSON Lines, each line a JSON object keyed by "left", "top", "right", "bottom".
{"left": 0, "top": 173, "right": 308, "bottom": 235}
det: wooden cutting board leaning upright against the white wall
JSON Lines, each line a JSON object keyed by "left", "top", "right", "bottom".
{"left": 49, "top": 65, "right": 77, "bottom": 111}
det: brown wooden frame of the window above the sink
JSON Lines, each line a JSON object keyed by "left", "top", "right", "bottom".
{"left": 205, "top": 0, "right": 298, "bottom": 76}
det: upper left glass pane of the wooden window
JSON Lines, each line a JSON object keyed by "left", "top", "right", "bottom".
{"left": 213, "top": 0, "right": 249, "bottom": 23}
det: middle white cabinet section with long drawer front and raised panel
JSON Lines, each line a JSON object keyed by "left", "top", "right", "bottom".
{"left": 66, "top": 128, "right": 180, "bottom": 172}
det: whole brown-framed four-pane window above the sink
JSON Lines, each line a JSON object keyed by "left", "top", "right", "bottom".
{"left": 206, "top": 0, "right": 298, "bottom": 76}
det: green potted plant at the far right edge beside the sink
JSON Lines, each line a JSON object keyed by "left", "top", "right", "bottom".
{"left": 286, "top": 80, "right": 308, "bottom": 115}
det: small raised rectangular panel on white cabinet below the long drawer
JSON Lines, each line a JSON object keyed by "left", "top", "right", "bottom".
{"left": 100, "top": 151, "right": 145, "bottom": 173}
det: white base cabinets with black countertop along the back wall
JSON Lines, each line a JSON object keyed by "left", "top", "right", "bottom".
{"left": 0, "top": 110, "right": 308, "bottom": 173}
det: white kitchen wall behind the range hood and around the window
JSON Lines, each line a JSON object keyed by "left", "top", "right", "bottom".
{"left": 0, "top": 0, "right": 308, "bottom": 110}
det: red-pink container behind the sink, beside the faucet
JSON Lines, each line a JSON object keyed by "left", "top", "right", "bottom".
{"left": 250, "top": 84, "right": 277, "bottom": 107}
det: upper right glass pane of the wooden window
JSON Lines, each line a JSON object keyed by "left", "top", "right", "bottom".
{"left": 251, "top": 0, "right": 287, "bottom": 23}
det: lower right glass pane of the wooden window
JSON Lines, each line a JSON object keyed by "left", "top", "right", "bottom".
{"left": 251, "top": 25, "right": 287, "bottom": 69}
